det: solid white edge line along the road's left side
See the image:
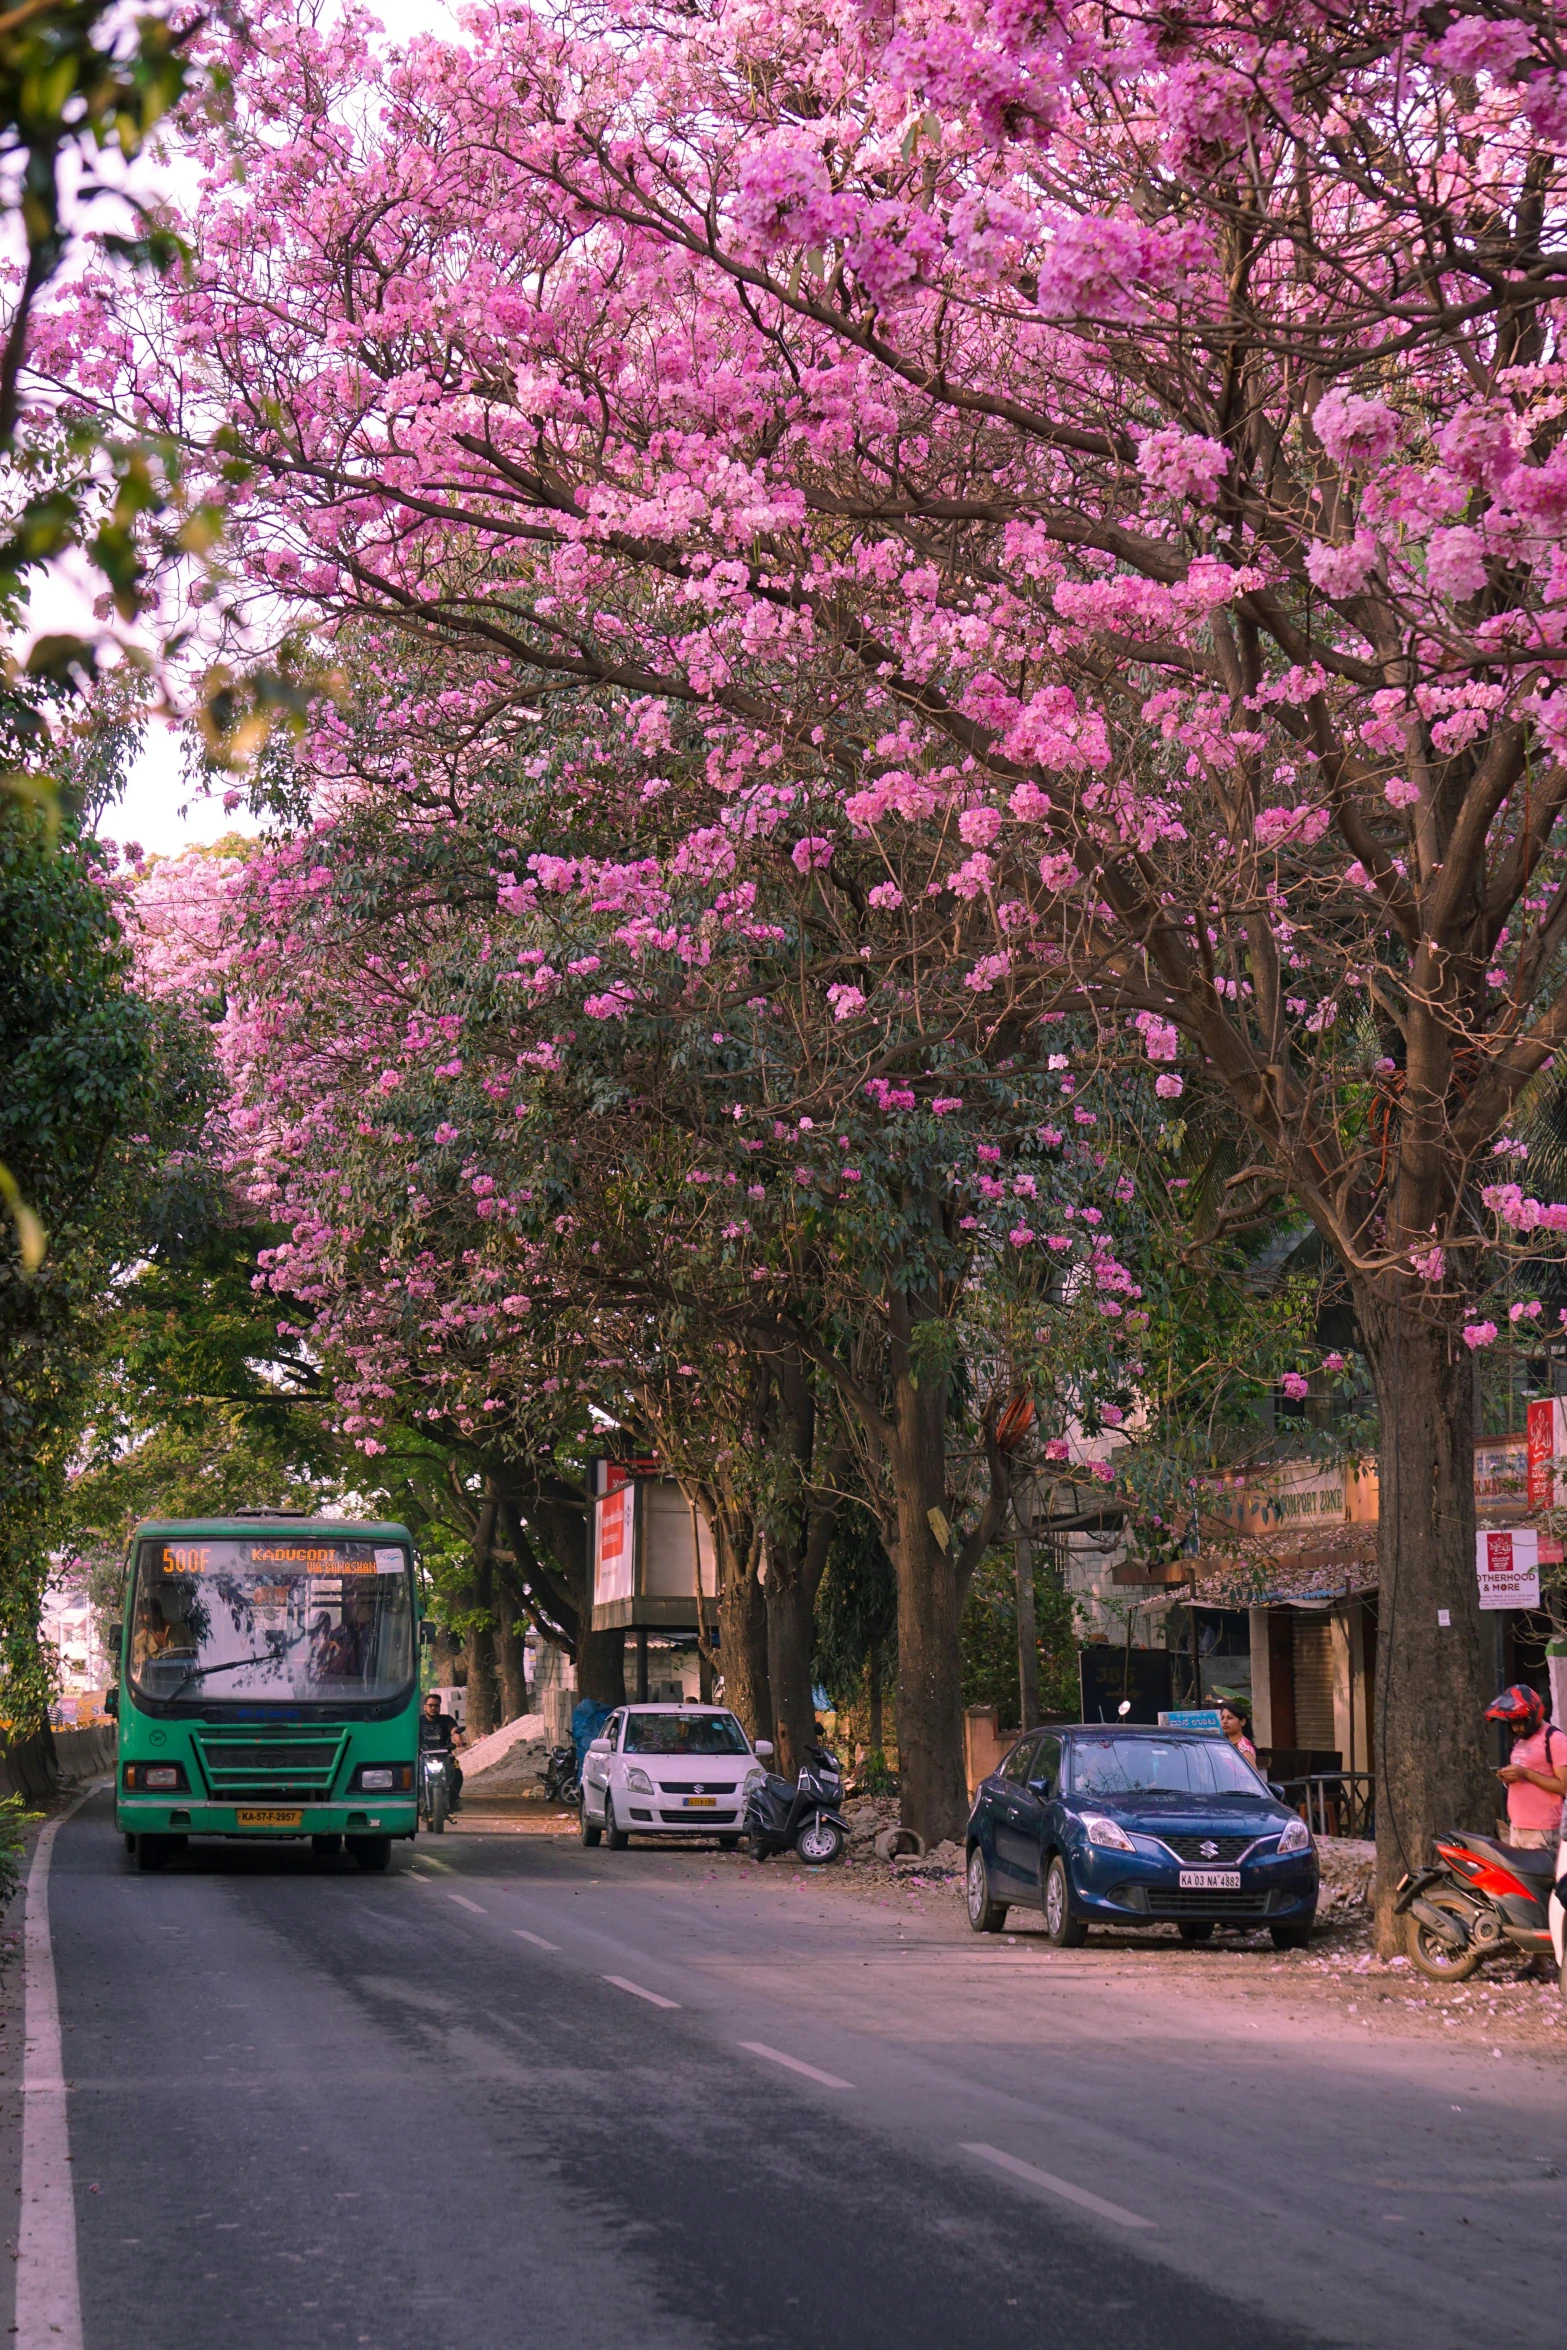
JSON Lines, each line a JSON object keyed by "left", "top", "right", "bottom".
{"left": 16, "top": 1788, "right": 92, "bottom": 2350}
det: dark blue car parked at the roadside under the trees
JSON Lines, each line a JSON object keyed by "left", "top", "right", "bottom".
{"left": 968, "top": 1723, "right": 1318, "bottom": 1951}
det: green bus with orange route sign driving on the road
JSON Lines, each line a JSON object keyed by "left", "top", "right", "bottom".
{"left": 110, "top": 1509, "right": 423, "bottom": 1868}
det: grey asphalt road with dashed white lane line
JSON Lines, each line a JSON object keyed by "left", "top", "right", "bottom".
{"left": 12, "top": 1795, "right": 1567, "bottom": 2350}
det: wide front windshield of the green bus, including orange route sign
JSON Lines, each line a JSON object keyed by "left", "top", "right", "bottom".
{"left": 129, "top": 1532, "right": 413, "bottom": 1706}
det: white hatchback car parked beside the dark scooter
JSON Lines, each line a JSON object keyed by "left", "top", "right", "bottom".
{"left": 583, "top": 1706, "right": 773, "bottom": 1852}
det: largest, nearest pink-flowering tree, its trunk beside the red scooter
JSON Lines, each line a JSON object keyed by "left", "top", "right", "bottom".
{"left": 73, "top": 0, "right": 1567, "bottom": 1892}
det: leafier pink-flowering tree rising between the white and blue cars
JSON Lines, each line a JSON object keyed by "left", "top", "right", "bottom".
{"left": 207, "top": 676, "right": 1188, "bottom": 1833}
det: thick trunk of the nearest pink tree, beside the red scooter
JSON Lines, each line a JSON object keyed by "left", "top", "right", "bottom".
{"left": 1356, "top": 1293, "right": 1497, "bottom": 1955}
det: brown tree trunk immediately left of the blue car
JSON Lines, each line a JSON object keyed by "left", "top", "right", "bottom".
{"left": 886, "top": 1365, "right": 968, "bottom": 1845}
